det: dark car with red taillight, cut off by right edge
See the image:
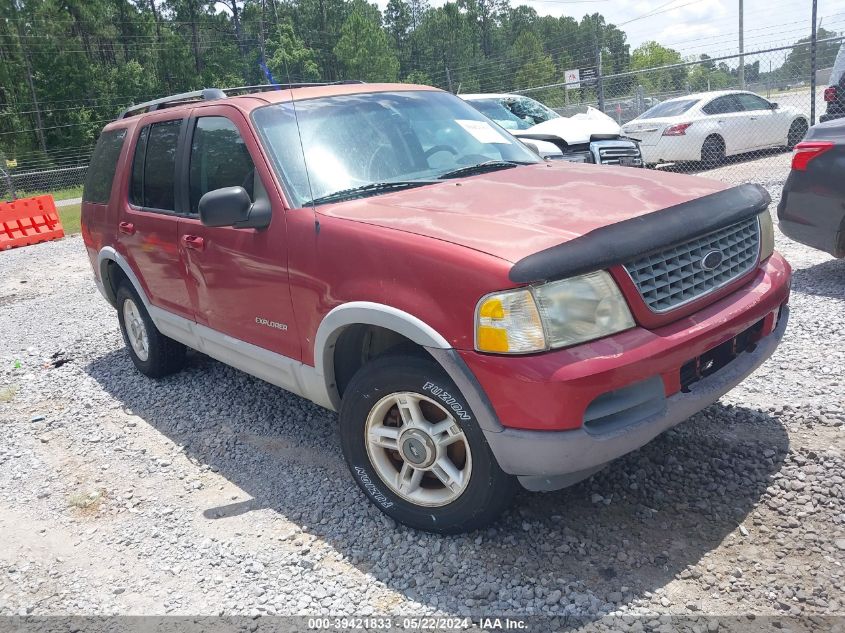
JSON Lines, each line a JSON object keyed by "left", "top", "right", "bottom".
{"left": 778, "top": 118, "right": 845, "bottom": 257}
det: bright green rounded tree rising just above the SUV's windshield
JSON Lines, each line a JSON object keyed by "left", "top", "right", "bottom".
{"left": 334, "top": 6, "right": 399, "bottom": 81}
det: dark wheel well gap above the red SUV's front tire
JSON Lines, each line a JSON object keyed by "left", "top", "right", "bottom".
{"left": 332, "top": 324, "right": 428, "bottom": 398}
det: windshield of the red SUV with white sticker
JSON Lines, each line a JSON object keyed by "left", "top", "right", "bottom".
{"left": 252, "top": 90, "right": 542, "bottom": 206}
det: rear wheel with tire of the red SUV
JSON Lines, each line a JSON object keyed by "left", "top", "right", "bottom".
{"left": 117, "top": 281, "right": 186, "bottom": 378}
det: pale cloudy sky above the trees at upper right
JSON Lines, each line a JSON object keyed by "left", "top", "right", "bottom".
{"left": 379, "top": 0, "right": 845, "bottom": 57}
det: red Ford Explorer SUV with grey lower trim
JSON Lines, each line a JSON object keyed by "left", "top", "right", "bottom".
{"left": 82, "top": 84, "right": 790, "bottom": 532}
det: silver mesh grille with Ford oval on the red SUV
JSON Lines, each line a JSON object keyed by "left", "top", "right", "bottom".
{"left": 625, "top": 218, "right": 760, "bottom": 312}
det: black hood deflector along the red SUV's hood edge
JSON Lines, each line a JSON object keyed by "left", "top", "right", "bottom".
{"left": 509, "top": 184, "right": 772, "bottom": 283}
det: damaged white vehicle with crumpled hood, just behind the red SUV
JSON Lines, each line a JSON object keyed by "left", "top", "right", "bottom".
{"left": 458, "top": 94, "right": 643, "bottom": 167}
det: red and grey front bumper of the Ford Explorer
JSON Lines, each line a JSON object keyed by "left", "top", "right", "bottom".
{"left": 460, "top": 253, "right": 791, "bottom": 490}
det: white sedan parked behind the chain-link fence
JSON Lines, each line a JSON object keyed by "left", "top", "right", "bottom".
{"left": 622, "top": 90, "right": 809, "bottom": 166}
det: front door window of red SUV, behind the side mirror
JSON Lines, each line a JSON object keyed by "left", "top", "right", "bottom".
{"left": 190, "top": 116, "right": 256, "bottom": 214}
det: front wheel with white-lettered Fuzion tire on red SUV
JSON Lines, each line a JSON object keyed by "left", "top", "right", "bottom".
{"left": 340, "top": 355, "right": 517, "bottom": 534}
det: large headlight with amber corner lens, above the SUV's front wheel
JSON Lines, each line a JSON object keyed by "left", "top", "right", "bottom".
{"left": 475, "top": 271, "right": 634, "bottom": 354}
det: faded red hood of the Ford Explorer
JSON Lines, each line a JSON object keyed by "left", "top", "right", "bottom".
{"left": 317, "top": 161, "right": 728, "bottom": 262}
